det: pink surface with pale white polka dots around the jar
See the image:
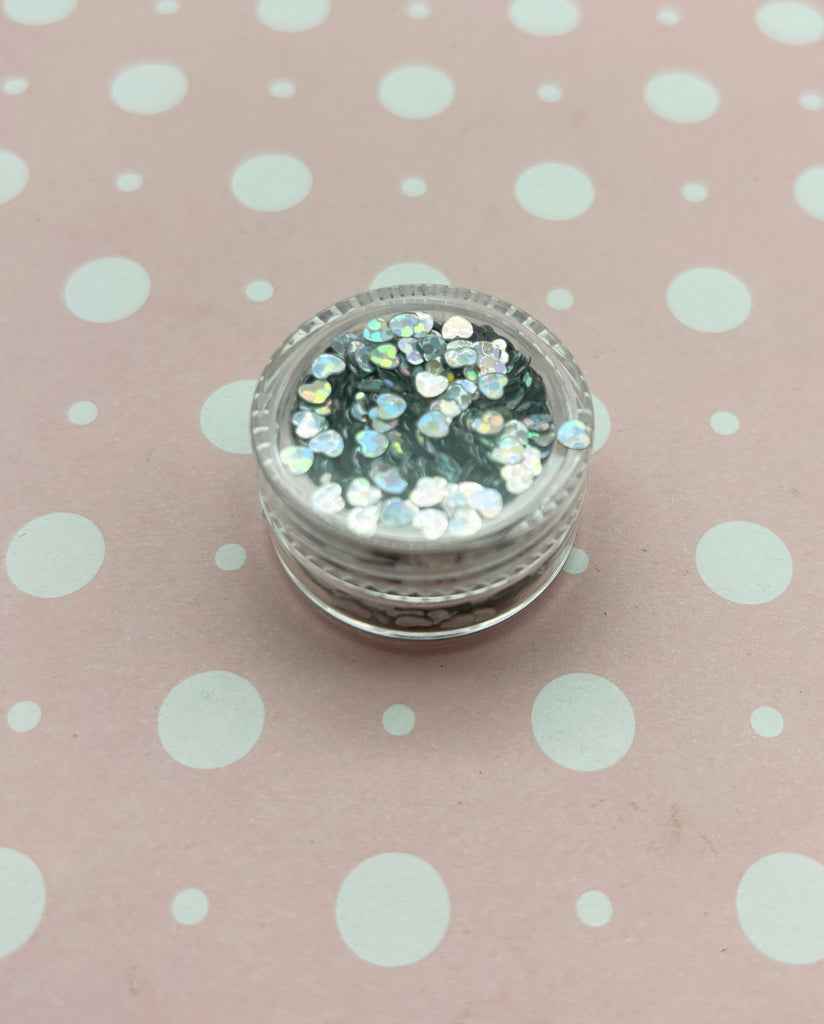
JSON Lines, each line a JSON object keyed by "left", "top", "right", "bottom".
{"left": 0, "top": 0, "right": 824, "bottom": 1024}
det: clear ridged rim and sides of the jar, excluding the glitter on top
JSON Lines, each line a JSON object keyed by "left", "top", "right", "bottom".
{"left": 252, "top": 285, "right": 594, "bottom": 640}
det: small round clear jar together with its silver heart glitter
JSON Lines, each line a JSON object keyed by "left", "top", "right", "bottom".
{"left": 252, "top": 285, "right": 594, "bottom": 640}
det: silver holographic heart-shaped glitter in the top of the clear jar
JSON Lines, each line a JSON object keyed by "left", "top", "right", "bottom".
{"left": 279, "top": 312, "right": 556, "bottom": 540}
